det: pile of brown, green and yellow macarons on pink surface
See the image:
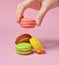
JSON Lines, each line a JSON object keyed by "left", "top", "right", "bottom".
{"left": 15, "top": 34, "right": 44, "bottom": 55}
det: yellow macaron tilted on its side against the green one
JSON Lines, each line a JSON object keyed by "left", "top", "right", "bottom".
{"left": 30, "top": 37, "right": 44, "bottom": 54}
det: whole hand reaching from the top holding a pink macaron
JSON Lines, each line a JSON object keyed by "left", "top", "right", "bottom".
{"left": 16, "top": 0, "right": 59, "bottom": 26}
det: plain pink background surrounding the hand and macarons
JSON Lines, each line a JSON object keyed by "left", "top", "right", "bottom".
{"left": 0, "top": 0, "right": 59, "bottom": 65}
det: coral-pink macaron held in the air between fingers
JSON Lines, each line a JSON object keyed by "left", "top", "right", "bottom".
{"left": 20, "top": 18, "right": 36, "bottom": 28}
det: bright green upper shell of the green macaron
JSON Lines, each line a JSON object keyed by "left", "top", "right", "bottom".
{"left": 16, "top": 42, "right": 32, "bottom": 51}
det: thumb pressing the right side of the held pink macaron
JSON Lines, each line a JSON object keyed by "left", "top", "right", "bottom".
{"left": 36, "top": 1, "right": 51, "bottom": 26}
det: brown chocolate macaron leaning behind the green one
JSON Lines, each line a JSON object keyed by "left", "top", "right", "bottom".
{"left": 15, "top": 33, "right": 31, "bottom": 44}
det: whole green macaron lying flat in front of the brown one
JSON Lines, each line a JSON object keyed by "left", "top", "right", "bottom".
{"left": 16, "top": 42, "right": 32, "bottom": 55}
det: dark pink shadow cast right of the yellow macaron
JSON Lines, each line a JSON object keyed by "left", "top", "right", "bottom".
{"left": 41, "top": 39, "right": 59, "bottom": 49}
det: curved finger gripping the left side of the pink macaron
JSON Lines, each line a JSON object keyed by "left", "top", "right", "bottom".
{"left": 16, "top": 0, "right": 34, "bottom": 22}
